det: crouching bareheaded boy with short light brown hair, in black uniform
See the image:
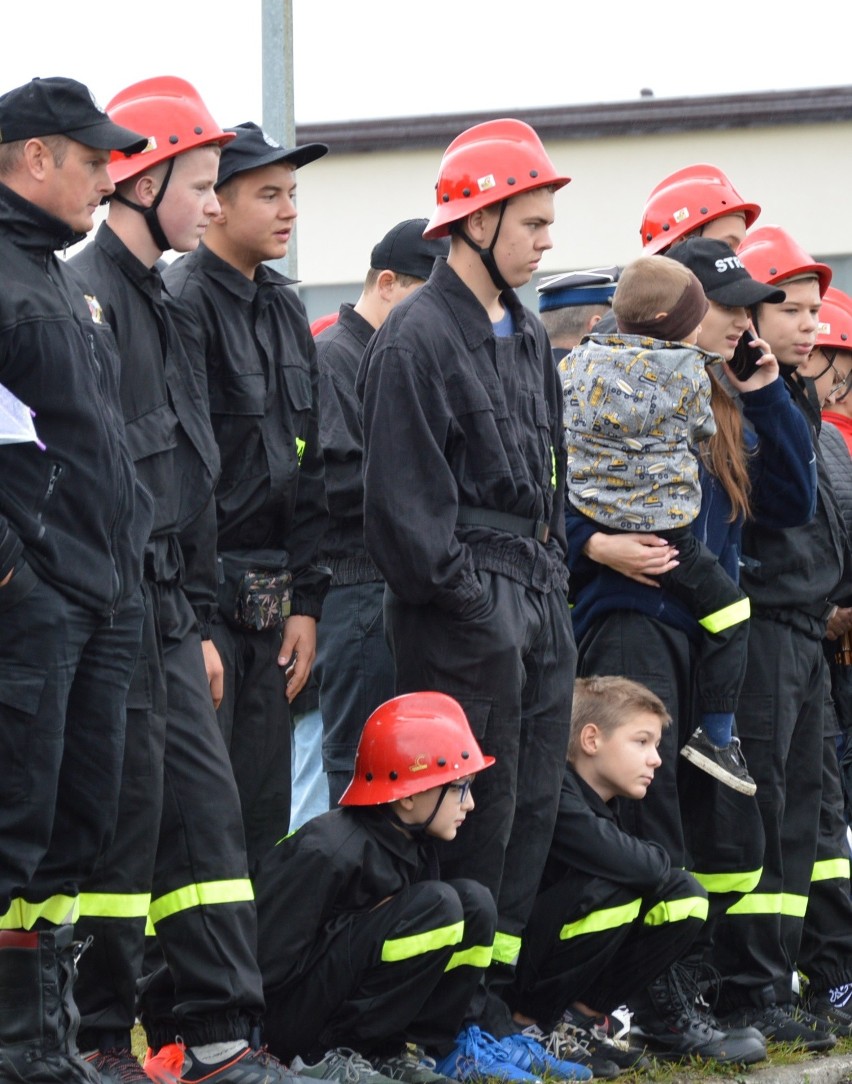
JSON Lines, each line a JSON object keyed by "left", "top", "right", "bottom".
{"left": 511, "top": 678, "right": 765, "bottom": 1075}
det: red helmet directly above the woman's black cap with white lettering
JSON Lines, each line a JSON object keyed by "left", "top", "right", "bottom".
{"left": 640, "top": 163, "right": 760, "bottom": 256}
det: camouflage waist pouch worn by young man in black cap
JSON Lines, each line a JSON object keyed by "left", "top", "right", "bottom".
{"left": 219, "top": 550, "right": 293, "bottom": 632}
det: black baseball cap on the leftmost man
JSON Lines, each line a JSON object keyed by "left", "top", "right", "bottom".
{"left": 0, "top": 76, "right": 147, "bottom": 154}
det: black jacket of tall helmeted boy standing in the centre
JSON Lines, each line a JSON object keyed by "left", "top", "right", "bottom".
{"left": 359, "top": 251, "right": 568, "bottom": 612}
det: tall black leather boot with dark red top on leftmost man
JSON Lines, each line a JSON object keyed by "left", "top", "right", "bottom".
{"left": 0, "top": 926, "right": 100, "bottom": 1084}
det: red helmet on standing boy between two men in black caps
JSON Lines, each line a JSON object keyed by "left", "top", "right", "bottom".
{"left": 106, "top": 75, "right": 235, "bottom": 184}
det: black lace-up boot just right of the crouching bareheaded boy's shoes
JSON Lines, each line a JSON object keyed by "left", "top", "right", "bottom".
{"left": 630, "top": 964, "right": 766, "bottom": 1066}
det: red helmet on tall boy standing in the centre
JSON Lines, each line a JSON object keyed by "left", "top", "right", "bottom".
{"left": 423, "top": 118, "right": 571, "bottom": 240}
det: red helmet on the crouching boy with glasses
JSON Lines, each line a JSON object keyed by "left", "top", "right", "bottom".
{"left": 340, "top": 693, "right": 494, "bottom": 805}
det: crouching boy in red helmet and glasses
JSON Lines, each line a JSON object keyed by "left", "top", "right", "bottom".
{"left": 249, "top": 693, "right": 591, "bottom": 1084}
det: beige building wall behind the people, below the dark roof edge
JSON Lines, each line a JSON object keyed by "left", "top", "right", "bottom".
{"left": 298, "top": 121, "right": 852, "bottom": 288}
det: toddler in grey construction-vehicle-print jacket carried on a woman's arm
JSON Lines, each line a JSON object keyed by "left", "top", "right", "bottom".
{"left": 564, "top": 256, "right": 756, "bottom": 795}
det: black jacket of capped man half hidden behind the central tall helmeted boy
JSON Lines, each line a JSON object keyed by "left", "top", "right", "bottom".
{"left": 317, "top": 304, "right": 382, "bottom": 584}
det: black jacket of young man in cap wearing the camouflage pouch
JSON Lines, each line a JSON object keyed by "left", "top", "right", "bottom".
{"left": 164, "top": 244, "right": 328, "bottom": 617}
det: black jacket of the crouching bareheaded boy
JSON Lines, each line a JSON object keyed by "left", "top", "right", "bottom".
{"left": 542, "top": 764, "right": 671, "bottom": 894}
